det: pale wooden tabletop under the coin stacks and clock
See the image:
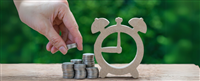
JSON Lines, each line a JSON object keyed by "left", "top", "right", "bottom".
{"left": 0, "top": 64, "right": 200, "bottom": 81}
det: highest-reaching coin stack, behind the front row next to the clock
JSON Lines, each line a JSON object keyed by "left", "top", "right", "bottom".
{"left": 82, "top": 53, "right": 94, "bottom": 67}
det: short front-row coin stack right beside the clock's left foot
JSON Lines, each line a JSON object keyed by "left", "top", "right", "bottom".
{"left": 86, "top": 67, "right": 99, "bottom": 78}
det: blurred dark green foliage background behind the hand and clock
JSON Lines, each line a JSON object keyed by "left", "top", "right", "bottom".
{"left": 0, "top": 0, "right": 200, "bottom": 65}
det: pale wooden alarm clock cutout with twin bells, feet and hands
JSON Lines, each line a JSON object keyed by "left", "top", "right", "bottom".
{"left": 92, "top": 17, "right": 147, "bottom": 78}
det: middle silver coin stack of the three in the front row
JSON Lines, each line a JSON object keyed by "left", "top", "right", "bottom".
{"left": 74, "top": 64, "right": 86, "bottom": 79}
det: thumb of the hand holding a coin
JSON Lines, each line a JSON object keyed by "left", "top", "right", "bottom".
{"left": 42, "top": 19, "right": 67, "bottom": 54}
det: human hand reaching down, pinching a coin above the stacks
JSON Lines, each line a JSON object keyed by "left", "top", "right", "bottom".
{"left": 14, "top": 0, "right": 83, "bottom": 54}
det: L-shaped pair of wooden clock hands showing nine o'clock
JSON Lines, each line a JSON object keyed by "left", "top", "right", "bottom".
{"left": 101, "top": 32, "right": 122, "bottom": 54}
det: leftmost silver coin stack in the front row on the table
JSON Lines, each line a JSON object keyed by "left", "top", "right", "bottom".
{"left": 62, "top": 62, "right": 74, "bottom": 78}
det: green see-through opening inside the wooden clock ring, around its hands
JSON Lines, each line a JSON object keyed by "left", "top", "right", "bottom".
{"left": 101, "top": 32, "right": 137, "bottom": 66}
